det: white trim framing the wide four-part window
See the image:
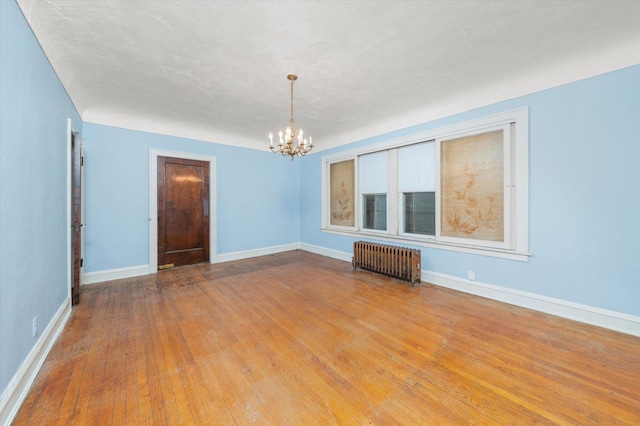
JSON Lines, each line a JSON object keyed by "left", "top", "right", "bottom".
{"left": 322, "top": 107, "right": 531, "bottom": 262}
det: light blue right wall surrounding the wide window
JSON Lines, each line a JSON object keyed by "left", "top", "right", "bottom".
{"left": 300, "top": 66, "right": 640, "bottom": 316}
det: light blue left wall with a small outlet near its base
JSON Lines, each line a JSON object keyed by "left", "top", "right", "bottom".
{"left": 0, "top": 1, "right": 82, "bottom": 400}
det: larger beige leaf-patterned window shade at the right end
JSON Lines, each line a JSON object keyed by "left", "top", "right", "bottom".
{"left": 440, "top": 130, "right": 505, "bottom": 242}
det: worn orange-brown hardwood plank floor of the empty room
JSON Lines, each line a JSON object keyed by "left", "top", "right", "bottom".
{"left": 15, "top": 251, "right": 640, "bottom": 425}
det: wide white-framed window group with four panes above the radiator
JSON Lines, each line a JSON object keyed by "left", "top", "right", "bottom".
{"left": 323, "top": 108, "right": 529, "bottom": 261}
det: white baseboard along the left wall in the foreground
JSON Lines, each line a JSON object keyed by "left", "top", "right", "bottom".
{"left": 0, "top": 297, "right": 71, "bottom": 426}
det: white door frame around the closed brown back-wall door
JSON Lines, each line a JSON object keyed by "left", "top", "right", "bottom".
{"left": 148, "top": 148, "right": 218, "bottom": 274}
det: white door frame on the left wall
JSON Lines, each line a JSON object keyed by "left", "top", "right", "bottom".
{"left": 66, "top": 118, "right": 84, "bottom": 306}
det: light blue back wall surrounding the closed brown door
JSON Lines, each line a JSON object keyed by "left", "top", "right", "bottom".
{"left": 83, "top": 123, "right": 300, "bottom": 272}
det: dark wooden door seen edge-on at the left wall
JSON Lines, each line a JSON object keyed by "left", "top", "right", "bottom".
{"left": 71, "top": 133, "right": 83, "bottom": 305}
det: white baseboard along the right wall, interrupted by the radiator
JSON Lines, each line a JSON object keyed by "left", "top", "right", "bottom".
{"left": 300, "top": 243, "right": 640, "bottom": 336}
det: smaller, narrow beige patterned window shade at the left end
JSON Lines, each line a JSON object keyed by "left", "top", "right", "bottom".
{"left": 329, "top": 160, "right": 355, "bottom": 226}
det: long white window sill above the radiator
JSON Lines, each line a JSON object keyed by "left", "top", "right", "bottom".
{"left": 322, "top": 228, "right": 531, "bottom": 262}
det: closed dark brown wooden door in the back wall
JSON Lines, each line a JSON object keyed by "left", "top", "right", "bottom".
{"left": 158, "top": 157, "right": 209, "bottom": 269}
